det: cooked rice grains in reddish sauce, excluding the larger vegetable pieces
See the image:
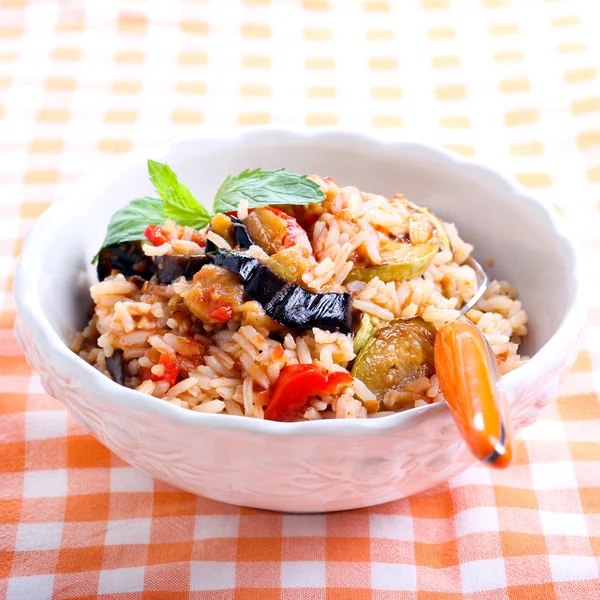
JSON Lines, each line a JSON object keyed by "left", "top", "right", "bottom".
{"left": 76, "top": 171, "right": 527, "bottom": 421}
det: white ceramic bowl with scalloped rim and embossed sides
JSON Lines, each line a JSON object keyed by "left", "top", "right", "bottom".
{"left": 16, "top": 130, "right": 586, "bottom": 512}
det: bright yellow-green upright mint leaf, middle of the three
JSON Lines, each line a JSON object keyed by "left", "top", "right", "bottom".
{"left": 148, "top": 160, "right": 211, "bottom": 229}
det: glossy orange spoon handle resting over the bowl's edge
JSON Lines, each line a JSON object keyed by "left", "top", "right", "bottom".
{"left": 434, "top": 319, "right": 512, "bottom": 468}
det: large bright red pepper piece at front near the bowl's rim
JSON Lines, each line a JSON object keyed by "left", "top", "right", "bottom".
{"left": 265, "top": 365, "right": 353, "bottom": 421}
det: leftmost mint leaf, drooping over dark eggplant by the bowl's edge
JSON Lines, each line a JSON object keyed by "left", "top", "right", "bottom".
{"left": 92, "top": 197, "right": 166, "bottom": 264}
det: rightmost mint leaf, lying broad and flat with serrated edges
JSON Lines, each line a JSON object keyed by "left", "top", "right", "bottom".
{"left": 213, "top": 169, "right": 325, "bottom": 213}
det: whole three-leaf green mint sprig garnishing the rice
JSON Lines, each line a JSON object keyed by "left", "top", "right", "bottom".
{"left": 92, "top": 160, "right": 325, "bottom": 263}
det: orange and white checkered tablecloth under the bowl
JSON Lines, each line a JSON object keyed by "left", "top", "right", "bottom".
{"left": 0, "top": 0, "right": 600, "bottom": 600}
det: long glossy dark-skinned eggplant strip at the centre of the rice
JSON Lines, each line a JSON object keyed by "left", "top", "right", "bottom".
{"left": 211, "top": 252, "right": 352, "bottom": 333}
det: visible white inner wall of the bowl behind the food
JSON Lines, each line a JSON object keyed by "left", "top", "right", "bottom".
{"left": 23, "top": 134, "right": 575, "bottom": 355}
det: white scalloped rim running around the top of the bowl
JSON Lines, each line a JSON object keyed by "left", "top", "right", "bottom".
{"left": 15, "top": 128, "right": 587, "bottom": 436}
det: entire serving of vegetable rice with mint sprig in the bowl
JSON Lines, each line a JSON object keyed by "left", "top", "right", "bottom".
{"left": 71, "top": 161, "right": 527, "bottom": 421}
